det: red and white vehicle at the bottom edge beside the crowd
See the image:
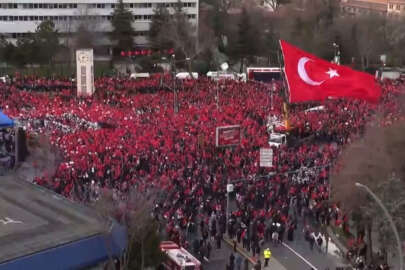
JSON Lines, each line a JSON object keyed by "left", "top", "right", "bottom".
{"left": 160, "top": 241, "right": 201, "bottom": 270}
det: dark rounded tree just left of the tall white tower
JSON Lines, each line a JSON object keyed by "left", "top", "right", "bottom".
{"left": 34, "top": 20, "right": 60, "bottom": 63}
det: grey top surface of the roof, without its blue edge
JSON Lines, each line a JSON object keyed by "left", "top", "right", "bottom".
{"left": 0, "top": 176, "right": 105, "bottom": 269}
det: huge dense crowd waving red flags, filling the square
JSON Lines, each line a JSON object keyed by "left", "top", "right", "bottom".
{"left": 0, "top": 74, "right": 405, "bottom": 270}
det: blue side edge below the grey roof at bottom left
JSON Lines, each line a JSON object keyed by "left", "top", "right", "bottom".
{"left": 0, "top": 222, "right": 128, "bottom": 270}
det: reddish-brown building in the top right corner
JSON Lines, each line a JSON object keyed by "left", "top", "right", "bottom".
{"left": 341, "top": 0, "right": 405, "bottom": 15}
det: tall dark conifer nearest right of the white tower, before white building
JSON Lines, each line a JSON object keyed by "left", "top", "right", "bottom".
{"left": 110, "top": 0, "right": 135, "bottom": 54}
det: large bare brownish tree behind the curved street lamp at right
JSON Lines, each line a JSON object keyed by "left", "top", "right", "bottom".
{"left": 331, "top": 121, "right": 405, "bottom": 264}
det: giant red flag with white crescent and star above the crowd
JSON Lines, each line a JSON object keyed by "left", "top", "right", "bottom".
{"left": 280, "top": 40, "right": 381, "bottom": 103}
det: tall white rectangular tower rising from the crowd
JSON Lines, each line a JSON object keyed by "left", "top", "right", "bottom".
{"left": 76, "top": 49, "right": 94, "bottom": 96}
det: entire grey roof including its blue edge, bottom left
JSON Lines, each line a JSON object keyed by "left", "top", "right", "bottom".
{"left": 0, "top": 177, "right": 126, "bottom": 270}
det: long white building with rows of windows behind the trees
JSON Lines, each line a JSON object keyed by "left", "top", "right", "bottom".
{"left": 0, "top": 0, "right": 199, "bottom": 48}
